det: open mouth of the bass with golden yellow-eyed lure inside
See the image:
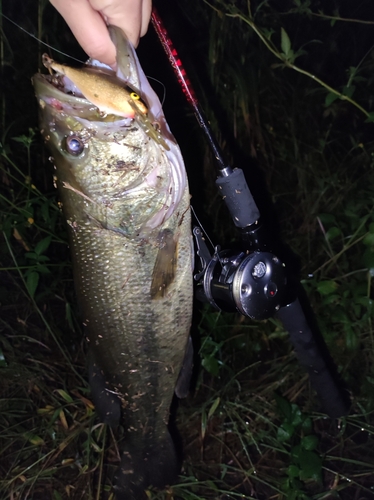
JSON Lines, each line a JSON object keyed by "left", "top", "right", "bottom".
{"left": 33, "top": 26, "right": 153, "bottom": 124}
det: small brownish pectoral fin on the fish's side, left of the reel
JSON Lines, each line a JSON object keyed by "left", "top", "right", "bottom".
{"left": 151, "top": 229, "right": 178, "bottom": 300}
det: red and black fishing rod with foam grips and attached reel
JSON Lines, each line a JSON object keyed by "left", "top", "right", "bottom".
{"left": 151, "top": 7, "right": 349, "bottom": 418}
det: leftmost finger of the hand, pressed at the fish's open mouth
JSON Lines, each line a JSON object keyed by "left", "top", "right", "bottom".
{"left": 50, "top": 0, "right": 116, "bottom": 66}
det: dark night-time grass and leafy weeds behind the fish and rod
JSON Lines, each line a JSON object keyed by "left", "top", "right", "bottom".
{"left": 0, "top": 0, "right": 374, "bottom": 500}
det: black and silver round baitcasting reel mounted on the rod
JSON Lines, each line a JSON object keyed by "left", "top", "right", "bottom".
{"left": 193, "top": 227, "right": 288, "bottom": 319}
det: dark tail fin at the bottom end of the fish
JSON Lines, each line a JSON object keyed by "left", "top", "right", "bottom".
{"left": 114, "top": 431, "right": 181, "bottom": 500}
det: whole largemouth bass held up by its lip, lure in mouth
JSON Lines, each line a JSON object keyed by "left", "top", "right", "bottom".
{"left": 33, "top": 27, "right": 193, "bottom": 500}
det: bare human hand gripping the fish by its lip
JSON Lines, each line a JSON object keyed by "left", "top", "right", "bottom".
{"left": 50, "top": 0, "right": 152, "bottom": 66}
